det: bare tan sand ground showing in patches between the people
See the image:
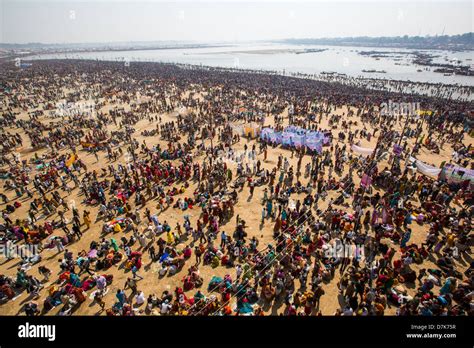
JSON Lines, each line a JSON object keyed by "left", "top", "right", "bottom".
{"left": 0, "top": 88, "right": 472, "bottom": 315}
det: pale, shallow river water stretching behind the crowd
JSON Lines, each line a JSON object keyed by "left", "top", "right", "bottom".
{"left": 28, "top": 44, "right": 474, "bottom": 86}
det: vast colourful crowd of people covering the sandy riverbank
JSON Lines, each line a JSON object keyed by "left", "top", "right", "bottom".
{"left": 0, "top": 60, "right": 474, "bottom": 316}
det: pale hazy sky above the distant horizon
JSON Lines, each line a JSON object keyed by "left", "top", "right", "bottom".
{"left": 0, "top": 0, "right": 474, "bottom": 43}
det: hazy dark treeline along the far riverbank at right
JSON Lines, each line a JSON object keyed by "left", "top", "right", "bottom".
{"left": 278, "top": 32, "right": 474, "bottom": 50}
